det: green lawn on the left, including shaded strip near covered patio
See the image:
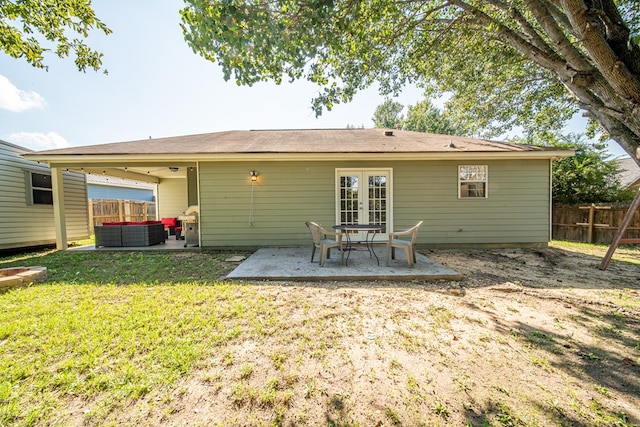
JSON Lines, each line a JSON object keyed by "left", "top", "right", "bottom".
{"left": 0, "top": 251, "right": 254, "bottom": 426}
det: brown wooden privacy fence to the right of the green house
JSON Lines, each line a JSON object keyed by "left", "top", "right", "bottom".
{"left": 552, "top": 203, "right": 640, "bottom": 245}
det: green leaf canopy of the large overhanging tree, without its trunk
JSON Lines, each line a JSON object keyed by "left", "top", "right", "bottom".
{"left": 182, "top": 0, "right": 576, "bottom": 136}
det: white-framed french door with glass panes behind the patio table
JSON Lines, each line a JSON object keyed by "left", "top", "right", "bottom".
{"left": 336, "top": 169, "right": 392, "bottom": 240}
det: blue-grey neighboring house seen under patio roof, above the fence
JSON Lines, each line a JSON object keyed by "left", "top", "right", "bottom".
{"left": 87, "top": 174, "right": 156, "bottom": 202}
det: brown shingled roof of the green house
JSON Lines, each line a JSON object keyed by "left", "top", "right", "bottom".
{"left": 26, "top": 129, "right": 557, "bottom": 157}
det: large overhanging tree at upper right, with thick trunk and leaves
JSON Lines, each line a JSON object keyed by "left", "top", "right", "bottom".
{"left": 181, "top": 0, "right": 640, "bottom": 162}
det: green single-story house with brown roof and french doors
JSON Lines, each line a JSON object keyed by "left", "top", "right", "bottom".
{"left": 26, "top": 129, "right": 573, "bottom": 248}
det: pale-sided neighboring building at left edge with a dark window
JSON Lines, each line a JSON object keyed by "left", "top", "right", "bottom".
{"left": 0, "top": 141, "right": 89, "bottom": 250}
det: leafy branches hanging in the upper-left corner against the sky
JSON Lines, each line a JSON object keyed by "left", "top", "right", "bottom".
{"left": 0, "top": 0, "right": 111, "bottom": 71}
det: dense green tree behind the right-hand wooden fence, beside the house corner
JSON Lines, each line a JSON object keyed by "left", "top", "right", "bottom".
{"left": 530, "top": 134, "right": 635, "bottom": 204}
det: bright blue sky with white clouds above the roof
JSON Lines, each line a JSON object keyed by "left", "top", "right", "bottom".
{"left": 0, "top": 0, "right": 622, "bottom": 155}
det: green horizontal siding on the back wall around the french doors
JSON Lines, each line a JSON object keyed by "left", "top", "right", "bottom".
{"left": 200, "top": 160, "right": 550, "bottom": 247}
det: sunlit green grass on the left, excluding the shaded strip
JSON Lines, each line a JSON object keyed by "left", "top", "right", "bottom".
{"left": 0, "top": 284, "right": 261, "bottom": 425}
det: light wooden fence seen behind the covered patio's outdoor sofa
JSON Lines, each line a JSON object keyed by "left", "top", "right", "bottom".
{"left": 89, "top": 199, "right": 156, "bottom": 233}
